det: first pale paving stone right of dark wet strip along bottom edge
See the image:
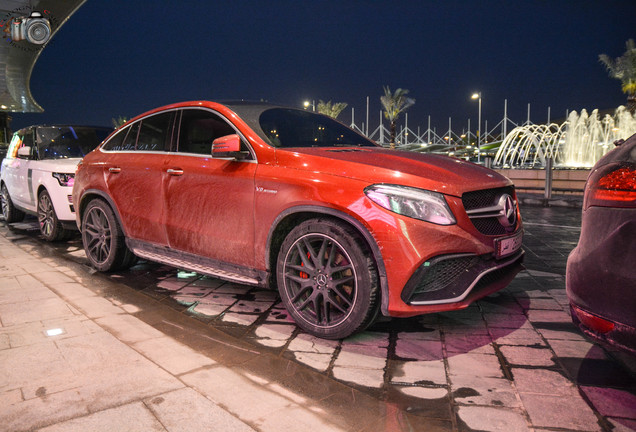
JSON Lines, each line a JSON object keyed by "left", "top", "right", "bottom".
{"left": 457, "top": 406, "right": 531, "bottom": 432}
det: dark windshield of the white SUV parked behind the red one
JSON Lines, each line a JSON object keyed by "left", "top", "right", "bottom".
{"left": 37, "top": 126, "right": 112, "bottom": 159}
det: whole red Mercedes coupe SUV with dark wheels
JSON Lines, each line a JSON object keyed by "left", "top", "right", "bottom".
{"left": 73, "top": 101, "right": 524, "bottom": 339}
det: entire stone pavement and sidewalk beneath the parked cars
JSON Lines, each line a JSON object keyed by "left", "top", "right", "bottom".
{"left": 0, "top": 207, "right": 636, "bottom": 432}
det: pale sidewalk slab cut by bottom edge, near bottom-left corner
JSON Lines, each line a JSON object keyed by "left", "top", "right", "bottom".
{"left": 40, "top": 402, "right": 169, "bottom": 432}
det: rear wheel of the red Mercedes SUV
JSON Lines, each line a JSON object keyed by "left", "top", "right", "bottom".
{"left": 82, "top": 199, "right": 133, "bottom": 272}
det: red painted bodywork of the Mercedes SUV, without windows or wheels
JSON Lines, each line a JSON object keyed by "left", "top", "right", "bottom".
{"left": 73, "top": 101, "right": 523, "bottom": 338}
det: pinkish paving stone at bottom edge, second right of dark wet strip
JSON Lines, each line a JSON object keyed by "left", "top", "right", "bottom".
{"left": 521, "top": 393, "right": 602, "bottom": 431}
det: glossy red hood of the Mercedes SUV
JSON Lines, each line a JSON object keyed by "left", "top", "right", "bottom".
{"left": 276, "top": 147, "right": 512, "bottom": 196}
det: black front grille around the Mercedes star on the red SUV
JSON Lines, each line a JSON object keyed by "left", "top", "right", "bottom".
{"left": 462, "top": 186, "right": 518, "bottom": 236}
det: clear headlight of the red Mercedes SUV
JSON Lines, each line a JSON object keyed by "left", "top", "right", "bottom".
{"left": 364, "top": 185, "right": 456, "bottom": 225}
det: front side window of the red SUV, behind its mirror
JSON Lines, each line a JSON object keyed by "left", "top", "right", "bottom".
{"left": 178, "top": 109, "right": 236, "bottom": 155}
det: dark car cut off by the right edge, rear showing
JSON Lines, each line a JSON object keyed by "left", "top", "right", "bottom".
{"left": 566, "top": 135, "right": 636, "bottom": 354}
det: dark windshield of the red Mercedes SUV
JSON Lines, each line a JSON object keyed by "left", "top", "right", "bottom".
{"left": 259, "top": 108, "right": 377, "bottom": 148}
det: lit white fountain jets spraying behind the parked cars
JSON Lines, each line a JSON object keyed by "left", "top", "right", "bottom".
{"left": 494, "top": 106, "right": 636, "bottom": 168}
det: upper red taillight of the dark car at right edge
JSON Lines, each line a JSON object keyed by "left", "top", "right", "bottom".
{"left": 584, "top": 164, "right": 636, "bottom": 208}
